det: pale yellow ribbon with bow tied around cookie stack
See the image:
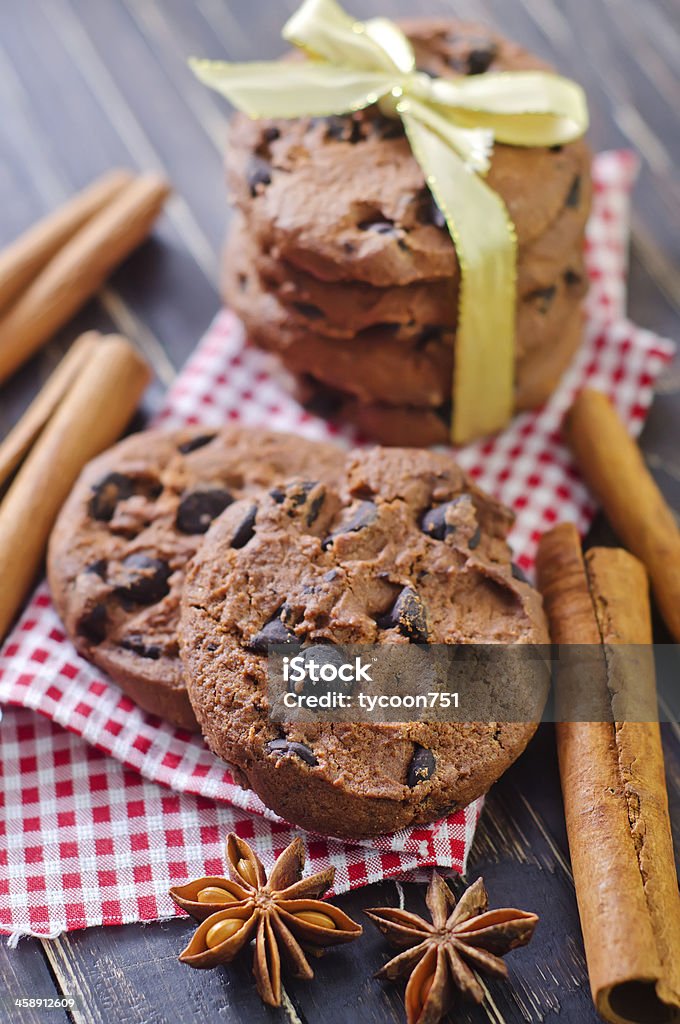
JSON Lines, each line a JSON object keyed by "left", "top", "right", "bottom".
{"left": 190, "top": 0, "right": 588, "bottom": 444}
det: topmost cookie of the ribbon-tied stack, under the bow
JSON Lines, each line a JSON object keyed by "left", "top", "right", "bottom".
{"left": 227, "top": 19, "right": 590, "bottom": 287}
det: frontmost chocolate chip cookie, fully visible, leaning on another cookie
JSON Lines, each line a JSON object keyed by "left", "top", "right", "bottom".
{"left": 180, "top": 449, "right": 548, "bottom": 837}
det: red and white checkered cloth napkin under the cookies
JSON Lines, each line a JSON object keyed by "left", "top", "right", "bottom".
{"left": 0, "top": 153, "right": 673, "bottom": 939}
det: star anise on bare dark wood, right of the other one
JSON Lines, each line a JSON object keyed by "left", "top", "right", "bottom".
{"left": 366, "top": 871, "right": 539, "bottom": 1024}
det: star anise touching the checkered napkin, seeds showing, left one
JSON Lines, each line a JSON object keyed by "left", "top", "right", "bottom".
{"left": 170, "top": 833, "right": 363, "bottom": 1007}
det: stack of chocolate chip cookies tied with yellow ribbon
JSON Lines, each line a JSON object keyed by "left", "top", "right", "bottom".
{"left": 224, "top": 20, "right": 591, "bottom": 444}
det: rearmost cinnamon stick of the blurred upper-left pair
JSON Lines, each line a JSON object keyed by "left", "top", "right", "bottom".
{"left": 0, "top": 170, "right": 132, "bottom": 312}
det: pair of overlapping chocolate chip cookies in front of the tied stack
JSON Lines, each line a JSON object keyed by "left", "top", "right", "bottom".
{"left": 48, "top": 427, "right": 548, "bottom": 837}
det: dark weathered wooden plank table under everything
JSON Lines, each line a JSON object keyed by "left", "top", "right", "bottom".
{"left": 0, "top": 0, "right": 680, "bottom": 1024}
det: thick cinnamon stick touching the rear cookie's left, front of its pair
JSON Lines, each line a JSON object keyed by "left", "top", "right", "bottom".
{"left": 0, "top": 335, "right": 151, "bottom": 640}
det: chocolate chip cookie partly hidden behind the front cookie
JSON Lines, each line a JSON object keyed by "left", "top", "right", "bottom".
{"left": 48, "top": 427, "right": 344, "bottom": 729}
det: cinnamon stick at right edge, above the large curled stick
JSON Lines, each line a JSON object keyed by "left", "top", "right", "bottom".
{"left": 565, "top": 388, "right": 680, "bottom": 642}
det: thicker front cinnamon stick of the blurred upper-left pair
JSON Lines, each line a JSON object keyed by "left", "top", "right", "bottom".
{"left": 0, "top": 174, "right": 170, "bottom": 383}
